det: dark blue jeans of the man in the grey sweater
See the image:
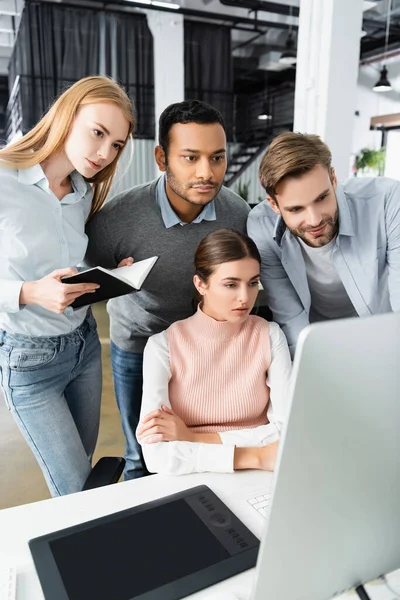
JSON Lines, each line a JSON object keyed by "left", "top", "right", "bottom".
{"left": 111, "top": 342, "right": 149, "bottom": 480}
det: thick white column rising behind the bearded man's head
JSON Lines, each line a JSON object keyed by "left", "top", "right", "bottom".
{"left": 293, "top": 0, "right": 363, "bottom": 181}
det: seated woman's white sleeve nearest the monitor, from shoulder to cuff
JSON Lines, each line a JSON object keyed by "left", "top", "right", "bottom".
{"left": 219, "top": 323, "right": 292, "bottom": 447}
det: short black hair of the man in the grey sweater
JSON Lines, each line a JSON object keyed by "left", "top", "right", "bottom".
{"left": 158, "top": 100, "right": 226, "bottom": 156}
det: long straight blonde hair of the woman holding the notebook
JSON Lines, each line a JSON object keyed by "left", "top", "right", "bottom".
{"left": 0, "top": 76, "right": 136, "bottom": 219}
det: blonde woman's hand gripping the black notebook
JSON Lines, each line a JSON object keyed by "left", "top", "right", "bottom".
{"left": 19, "top": 269, "right": 100, "bottom": 314}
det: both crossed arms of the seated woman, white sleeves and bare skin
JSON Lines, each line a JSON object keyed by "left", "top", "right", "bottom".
{"left": 136, "top": 323, "right": 291, "bottom": 475}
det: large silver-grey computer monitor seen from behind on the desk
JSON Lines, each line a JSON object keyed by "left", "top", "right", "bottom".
{"left": 253, "top": 313, "right": 400, "bottom": 600}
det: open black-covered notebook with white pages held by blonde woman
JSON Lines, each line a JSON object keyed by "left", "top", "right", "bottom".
{"left": 62, "top": 256, "right": 158, "bottom": 308}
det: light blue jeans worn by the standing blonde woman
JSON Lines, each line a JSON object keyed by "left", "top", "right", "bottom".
{"left": 0, "top": 310, "right": 102, "bottom": 496}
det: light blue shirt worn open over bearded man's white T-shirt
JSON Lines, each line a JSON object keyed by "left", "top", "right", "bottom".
{"left": 247, "top": 177, "right": 400, "bottom": 355}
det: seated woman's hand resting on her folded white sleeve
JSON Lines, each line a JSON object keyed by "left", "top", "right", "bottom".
{"left": 137, "top": 404, "right": 194, "bottom": 444}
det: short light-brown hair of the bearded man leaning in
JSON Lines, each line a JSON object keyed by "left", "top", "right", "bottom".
{"left": 258, "top": 131, "right": 332, "bottom": 200}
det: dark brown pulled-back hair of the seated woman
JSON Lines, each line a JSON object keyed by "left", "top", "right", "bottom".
{"left": 194, "top": 229, "right": 261, "bottom": 283}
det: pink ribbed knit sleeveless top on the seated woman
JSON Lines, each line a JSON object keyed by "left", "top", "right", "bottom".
{"left": 167, "top": 308, "right": 271, "bottom": 433}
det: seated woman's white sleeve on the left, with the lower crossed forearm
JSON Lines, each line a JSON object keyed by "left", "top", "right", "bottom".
{"left": 139, "top": 331, "right": 235, "bottom": 475}
